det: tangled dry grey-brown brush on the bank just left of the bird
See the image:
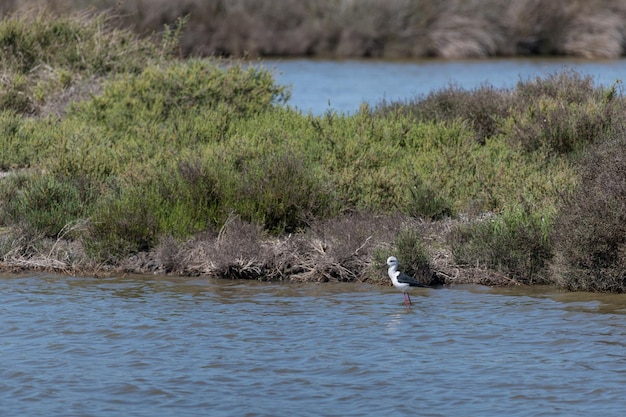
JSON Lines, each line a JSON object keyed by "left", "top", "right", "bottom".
{"left": 151, "top": 213, "right": 412, "bottom": 282}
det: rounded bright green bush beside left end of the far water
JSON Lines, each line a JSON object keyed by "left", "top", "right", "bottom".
{"left": 71, "top": 60, "right": 289, "bottom": 127}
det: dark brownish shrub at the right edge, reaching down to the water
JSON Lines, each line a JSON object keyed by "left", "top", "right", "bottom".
{"left": 552, "top": 133, "right": 626, "bottom": 292}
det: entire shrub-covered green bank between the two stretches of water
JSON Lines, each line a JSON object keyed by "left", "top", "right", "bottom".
{"left": 0, "top": 9, "right": 626, "bottom": 291}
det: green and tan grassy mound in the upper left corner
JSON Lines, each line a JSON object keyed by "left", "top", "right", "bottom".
{"left": 0, "top": 11, "right": 174, "bottom": 114}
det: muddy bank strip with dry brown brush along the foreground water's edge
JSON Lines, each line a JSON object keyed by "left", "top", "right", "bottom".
{"left": 0, "top": 213, "right": 522, "bottom": 286}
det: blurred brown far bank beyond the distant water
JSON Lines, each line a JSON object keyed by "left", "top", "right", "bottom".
{"left": 0, "top": 0, "right": 626, "bottom": 59}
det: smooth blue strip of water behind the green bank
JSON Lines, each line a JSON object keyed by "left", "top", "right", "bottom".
{"left": 265, "top": 58, "right": 626, "bottom": 115}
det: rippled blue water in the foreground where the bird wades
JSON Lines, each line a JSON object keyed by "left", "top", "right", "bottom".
{"left": 0, "top": 271, "right": 626, "bottom": 417}
